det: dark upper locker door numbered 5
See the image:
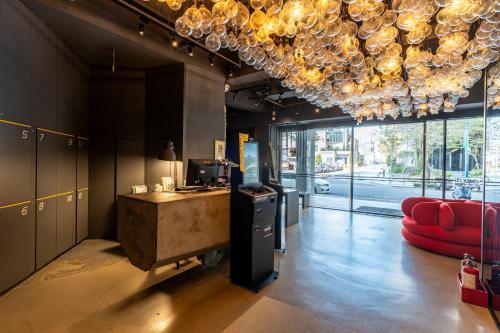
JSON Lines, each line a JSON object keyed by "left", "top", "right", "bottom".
{"left": 0, "top": 121, "right": 35, "bottom": 207}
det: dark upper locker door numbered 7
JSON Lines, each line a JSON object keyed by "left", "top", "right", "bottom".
{"left": 36, "top": 130, "right": 59, "bottom": 198}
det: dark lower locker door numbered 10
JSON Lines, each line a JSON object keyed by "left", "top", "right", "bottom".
{"left": 57, "top": 192, "right": 76, "bottom": 255}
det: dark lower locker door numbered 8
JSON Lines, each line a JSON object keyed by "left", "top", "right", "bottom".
{"left": 35, "top": 196, "right": 57, "bottom": 269}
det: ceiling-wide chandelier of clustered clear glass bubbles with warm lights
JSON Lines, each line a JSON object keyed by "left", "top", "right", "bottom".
{"left": 157, "top": 0, "right": 500, "bottom": 123}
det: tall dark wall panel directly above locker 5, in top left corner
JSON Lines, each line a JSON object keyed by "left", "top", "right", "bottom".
{"left": 0, "top": 0, "right": 31, "bottom": 124}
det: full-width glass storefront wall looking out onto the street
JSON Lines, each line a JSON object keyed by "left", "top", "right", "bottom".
{"left": 272, "top": 113, "right": 486, "bottom": 215}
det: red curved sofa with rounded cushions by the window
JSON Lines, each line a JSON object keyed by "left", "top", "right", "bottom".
{"left": 401, "top": 197, "right": 499, "bottom": 259}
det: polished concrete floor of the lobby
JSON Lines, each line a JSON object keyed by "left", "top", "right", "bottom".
{"left": 0, "top": 208, "right": 496, "bottom": 333}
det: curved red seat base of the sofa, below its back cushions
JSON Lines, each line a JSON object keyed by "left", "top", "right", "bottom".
{"left": 403, "top": 216, "right": 481, "bottom": 246}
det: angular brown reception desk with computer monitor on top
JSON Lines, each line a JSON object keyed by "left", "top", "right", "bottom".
{"left": 117, "top": 190, "right": 230, "bottom": 271}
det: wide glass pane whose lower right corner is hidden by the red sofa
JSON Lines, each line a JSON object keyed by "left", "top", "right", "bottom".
{"left": 353, "top": 123, "right": 423, "bottom": 215}
